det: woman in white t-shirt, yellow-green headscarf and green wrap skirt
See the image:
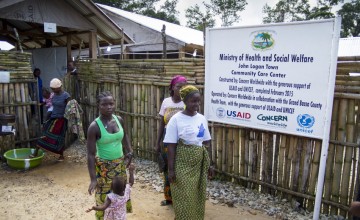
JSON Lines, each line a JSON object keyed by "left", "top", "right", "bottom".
{"left": 164, "top": 85, "right": 213, "bottom": 220}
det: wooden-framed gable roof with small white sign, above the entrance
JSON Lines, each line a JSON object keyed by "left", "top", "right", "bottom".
{"left": 0, "top": 0, "right": 134, "bottom": 59}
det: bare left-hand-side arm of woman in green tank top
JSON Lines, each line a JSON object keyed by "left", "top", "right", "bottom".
{"left": 86, "top": 121, "right": 98, "bottom": 195}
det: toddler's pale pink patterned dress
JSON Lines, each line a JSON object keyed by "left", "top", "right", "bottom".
{"left": 104, "top": 184, "right": 131, "bottom": 220}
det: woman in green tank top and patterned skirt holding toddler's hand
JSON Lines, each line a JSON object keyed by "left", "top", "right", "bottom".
{"left": 87, "top": 92, "right": 133, "bottom": 219}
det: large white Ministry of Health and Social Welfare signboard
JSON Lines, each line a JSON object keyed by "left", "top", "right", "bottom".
{"left": 205, "top": 19, "right": 338, "bottom": 139}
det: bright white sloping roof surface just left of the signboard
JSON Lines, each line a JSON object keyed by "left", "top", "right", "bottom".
{"left": 97, "top": 4, "right": 204, "bottom": 46}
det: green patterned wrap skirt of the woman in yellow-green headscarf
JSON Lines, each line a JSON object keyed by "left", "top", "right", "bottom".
{"left": 170, "top": 141, "right": 210, "bottom": 220}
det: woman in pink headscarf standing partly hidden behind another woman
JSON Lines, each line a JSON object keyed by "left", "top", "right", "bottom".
{"left": 155, "top": 75, "right": 186, "bottom": 206}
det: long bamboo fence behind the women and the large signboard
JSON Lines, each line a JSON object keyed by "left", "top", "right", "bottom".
{"left": 56, "top": 57, "right": 360, "bottom": 217}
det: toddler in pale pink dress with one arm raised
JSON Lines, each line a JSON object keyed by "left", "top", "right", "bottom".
{"left": 86, "top": 164, "right": 135, "bottom": 220}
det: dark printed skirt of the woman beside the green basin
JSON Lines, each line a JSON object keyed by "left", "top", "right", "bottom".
{"left": 36, "top": 118, "right": 67, "bottom": 154}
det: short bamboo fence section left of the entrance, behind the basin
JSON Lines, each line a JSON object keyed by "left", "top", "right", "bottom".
{"left": 0, "top": 51, "right": 38, "bottom": 153}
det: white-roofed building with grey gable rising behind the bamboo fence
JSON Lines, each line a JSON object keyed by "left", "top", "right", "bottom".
{"left": 97, "top": 4, "right": 204, "bottom": 58}
